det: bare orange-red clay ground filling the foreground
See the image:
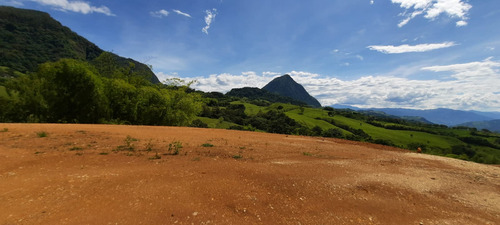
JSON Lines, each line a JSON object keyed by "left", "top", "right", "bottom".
{"left": 0, "top": 124, "right": 500, "bottom": 225}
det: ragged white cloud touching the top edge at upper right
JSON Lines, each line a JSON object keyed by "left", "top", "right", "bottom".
{"left": 391, "top": 0, "right": 472, "bottom": 27}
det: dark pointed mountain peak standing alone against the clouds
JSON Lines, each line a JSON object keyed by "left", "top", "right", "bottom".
{"left": 262, "top": 74, "right": 321, "bottom": 107}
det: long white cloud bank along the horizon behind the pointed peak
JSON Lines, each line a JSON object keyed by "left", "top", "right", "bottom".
{"left": 160, "top": 58, "right": 500, "bottom": 111}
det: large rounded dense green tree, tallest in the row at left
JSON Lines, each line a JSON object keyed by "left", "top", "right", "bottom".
{"left": 34, "top": 59, "right": 109, "bottom": 123}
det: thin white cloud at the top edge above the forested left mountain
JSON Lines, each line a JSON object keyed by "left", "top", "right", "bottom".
{"left": 31, "top": 0, "right": 115, "bottom": 16}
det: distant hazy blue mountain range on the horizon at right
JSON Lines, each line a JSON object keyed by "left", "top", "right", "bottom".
{"left": 332, "top": 105, "right": 500, "bottom": 132}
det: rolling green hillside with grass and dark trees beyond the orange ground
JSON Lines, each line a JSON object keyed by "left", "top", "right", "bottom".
{"left": 199, "top": 98, "right": 500, "bottom": 164}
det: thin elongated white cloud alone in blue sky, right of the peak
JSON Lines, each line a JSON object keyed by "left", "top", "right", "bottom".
{"left": 367, "top": 42, "right": 455, "bottom": 54}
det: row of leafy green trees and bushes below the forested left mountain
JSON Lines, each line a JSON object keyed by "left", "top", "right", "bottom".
{"left": 0, "top": 59, "right": 202, "bottom": 126}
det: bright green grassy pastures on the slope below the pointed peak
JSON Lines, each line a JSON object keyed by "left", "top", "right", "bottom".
{"left": 202, "top": 100, "right": 500, "bottom": 164}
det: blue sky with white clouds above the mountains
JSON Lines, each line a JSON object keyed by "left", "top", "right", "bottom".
{"left": 0, "top": 0, "right": 500, "bottom": 111}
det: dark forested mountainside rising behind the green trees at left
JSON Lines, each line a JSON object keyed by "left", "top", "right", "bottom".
{"left": 0, "top": 6, "right": 159, "bottom": 83}
